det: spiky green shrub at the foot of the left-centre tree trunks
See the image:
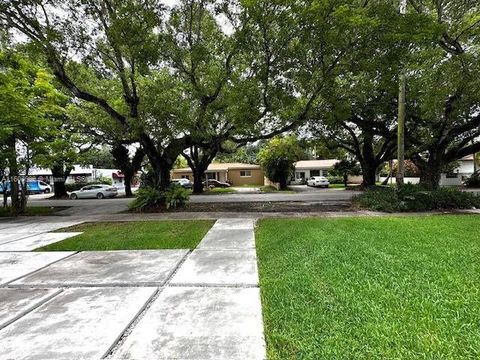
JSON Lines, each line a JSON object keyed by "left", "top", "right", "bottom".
{"left": 129, "top": 185, "right": 190, "bottom": 211}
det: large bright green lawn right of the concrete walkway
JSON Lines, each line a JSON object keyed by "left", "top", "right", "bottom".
{"left": 256, "top": 215, "right": 480, "bottom": 360}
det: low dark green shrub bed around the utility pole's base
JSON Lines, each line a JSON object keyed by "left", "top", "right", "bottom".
{"left": 353, "top": 184, "right": 480, "bottom": 212}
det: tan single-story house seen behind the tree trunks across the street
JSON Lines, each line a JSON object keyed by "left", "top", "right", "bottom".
{"left": 172, "top": 163, "right": 265, "bottom": 186}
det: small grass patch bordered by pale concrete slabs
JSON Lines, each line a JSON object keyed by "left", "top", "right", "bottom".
{"left": 37, "top": 220, "right": 214, "bottom": 251}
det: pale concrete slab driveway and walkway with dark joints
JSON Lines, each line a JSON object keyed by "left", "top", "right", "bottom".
{"left": 0, "top": 218, "right": 266, "bottom": 360}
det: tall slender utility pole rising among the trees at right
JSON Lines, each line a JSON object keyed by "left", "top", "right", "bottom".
{"left": 397, "top": 0, "right": 407, "bottom": 187}
